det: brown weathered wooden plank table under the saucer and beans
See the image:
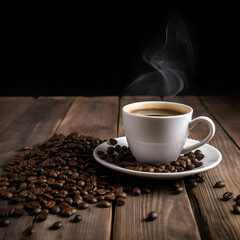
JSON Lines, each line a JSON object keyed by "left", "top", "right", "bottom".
{"left": 0, "top": 96, "right": 240, "bottom": 240}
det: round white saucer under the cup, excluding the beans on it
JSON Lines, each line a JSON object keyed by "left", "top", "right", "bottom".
{"left": 93, "top": 137, "right": 222, "bottom": 179}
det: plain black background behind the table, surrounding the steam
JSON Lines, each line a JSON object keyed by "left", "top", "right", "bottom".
{"left": 0, "top": 2, "right": 239, "bottom": 96}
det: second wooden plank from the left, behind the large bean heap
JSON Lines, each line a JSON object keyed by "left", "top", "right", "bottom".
{"left": 0, "top": 97, "right": 73, "bottom": 240}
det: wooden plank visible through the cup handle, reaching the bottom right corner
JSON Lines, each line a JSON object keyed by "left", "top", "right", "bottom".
{"left": 166, "top": 96, "right": 240, "bottom": 240}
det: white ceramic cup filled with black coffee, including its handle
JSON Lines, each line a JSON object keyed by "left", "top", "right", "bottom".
{"left": 122, "top": 101, "right": 215, "bottom": 163}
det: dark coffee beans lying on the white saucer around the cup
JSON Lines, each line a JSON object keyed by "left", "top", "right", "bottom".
{"left": 97, "top": 140, "right": 204, "bottom": 173}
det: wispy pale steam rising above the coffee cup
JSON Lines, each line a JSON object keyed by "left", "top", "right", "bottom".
{"left": 124, "top": 15, "right": 193, "bottom": 98}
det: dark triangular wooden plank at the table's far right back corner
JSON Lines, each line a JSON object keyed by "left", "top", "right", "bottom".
{"left": 200, "top": 96, "right": 240, "bottom": 147}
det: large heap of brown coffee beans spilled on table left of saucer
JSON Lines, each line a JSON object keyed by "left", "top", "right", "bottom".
{"left": 0, "top": 132, "right": 150, "bottom": 232}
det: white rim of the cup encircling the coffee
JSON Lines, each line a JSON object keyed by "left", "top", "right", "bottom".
{"left": 122, "top": 101, "right": 193, "bottom": 119}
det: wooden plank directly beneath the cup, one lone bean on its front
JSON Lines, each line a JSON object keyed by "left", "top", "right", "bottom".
{"left": 113, "top": 97, "right": 200, "bottom": 240}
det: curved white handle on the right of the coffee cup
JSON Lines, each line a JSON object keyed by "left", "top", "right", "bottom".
{"left": 181, "top": 116, "right": 215, "bottom": 154}
